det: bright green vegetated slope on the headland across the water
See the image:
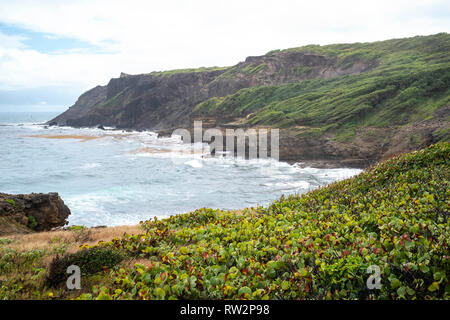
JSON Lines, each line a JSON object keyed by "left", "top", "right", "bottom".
{"left": 195, "top": 33, "right": 450, "bottom": 141}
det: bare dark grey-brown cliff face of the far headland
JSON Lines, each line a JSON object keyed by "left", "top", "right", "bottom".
{"left": 49, "top": 52, "right": 372, "bottom": 130}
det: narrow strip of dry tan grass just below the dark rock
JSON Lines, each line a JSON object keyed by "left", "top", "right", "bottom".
{"left": 4, "top": 225, "right": 144, "bottom": 252}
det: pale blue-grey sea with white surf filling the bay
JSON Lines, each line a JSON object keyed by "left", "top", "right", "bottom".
{"left": 0, "top": 113, "right": 360, "bottom": 226}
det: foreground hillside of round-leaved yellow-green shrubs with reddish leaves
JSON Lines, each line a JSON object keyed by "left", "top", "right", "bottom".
{"left": 0, "top": 143, "right": 450, "bottom": 299}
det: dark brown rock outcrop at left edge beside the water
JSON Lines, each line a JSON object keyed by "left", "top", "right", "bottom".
{"left": 0, "top": 193, "right": 70, "bottom": 235}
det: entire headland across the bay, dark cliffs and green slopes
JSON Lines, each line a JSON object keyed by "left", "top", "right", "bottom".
{"left": 49, "top": 33, "right": 450, "bottom": 166}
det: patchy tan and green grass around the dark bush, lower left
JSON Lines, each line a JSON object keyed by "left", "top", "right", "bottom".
{"left": 0, "top": 225, "right": 151, "bottom": 300}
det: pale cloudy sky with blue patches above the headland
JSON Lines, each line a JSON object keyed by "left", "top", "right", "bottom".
{"left": 0, "top": 0, "right": 450, "bottom": 111}
